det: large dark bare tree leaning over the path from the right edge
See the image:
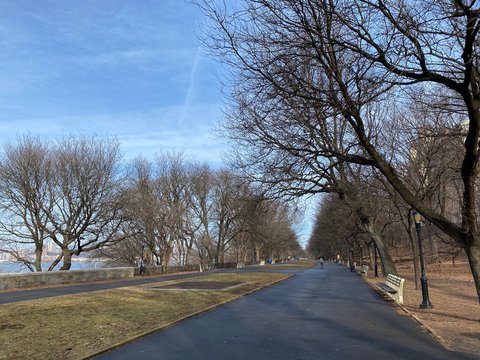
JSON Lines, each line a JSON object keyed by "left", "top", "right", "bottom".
{"left": 202, "top": 0, "right": 480, "bottom": 300}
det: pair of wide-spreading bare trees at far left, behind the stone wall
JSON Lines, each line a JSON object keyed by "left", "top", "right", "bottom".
{"left": 0, "top": 136, "right": 124, "bottom": 271}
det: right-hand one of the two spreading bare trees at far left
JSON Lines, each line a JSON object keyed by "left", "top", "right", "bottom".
{"left": 43, "top": 137, "right": 125, "bottom": 270}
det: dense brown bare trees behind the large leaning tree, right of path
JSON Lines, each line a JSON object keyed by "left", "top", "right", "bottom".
{"left": 308, "top": 108, "right": 468, "bottom": 281}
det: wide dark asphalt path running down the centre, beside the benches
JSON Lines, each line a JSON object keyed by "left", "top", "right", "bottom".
{"left": 96, "top": 263, "right": 475, "bottom": 360}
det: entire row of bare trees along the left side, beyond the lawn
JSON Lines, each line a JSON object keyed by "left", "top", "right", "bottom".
{"left": 0, "top": 135, "right": 299, "bottom": 271}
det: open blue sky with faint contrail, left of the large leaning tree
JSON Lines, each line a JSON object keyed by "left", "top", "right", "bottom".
{"left": 0, "top": 0, "right": 226, "bottom": 164}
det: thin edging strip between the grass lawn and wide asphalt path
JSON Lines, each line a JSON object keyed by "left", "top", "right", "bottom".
{"left": 80, "top": 274, "right": 295, "bottom": 360}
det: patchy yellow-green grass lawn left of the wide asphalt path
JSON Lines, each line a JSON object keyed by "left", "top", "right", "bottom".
{"left": 0, "top": 273, "right": 288, "bottom": 360}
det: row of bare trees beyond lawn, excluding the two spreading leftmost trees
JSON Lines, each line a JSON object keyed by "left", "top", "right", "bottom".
{"left": 102, "top": 153, "right": 300, "bottom": 267}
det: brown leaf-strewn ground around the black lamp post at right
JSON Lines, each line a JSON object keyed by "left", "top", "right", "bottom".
{"left": 369, "top": 261, "right": 480, "bottom": 354}
